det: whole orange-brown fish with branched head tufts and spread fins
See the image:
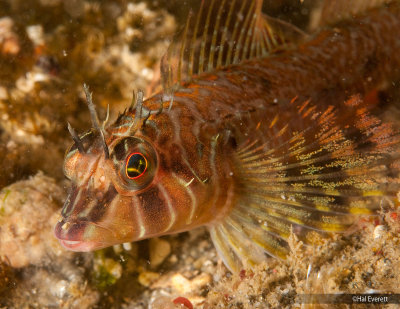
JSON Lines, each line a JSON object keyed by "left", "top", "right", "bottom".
{"left": 55, "top": 0, "right": 400, "bottom": 271}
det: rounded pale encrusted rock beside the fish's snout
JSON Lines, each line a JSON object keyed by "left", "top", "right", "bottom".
{"left": 0, "top": 173, "right": 67, "bottom": 268}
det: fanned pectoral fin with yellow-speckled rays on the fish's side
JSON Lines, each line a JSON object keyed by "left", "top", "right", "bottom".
{"left": 209, "top": 97, "right": 400, "bottom": 269}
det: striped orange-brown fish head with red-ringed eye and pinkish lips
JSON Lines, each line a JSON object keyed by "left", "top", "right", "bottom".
{"left": 55, "top": 110, "right": 216, "bottom": 251}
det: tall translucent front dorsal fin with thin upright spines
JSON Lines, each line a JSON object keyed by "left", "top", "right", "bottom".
{"left": 161, "top": 0, "right": 303, "bottom": 89}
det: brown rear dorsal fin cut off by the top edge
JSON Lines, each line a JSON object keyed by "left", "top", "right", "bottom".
{"left": 310, "top": 0, "right": 392, "bottom": 29}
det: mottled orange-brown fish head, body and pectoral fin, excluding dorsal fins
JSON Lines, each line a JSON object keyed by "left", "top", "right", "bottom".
{"left": 55, "top": 2, "right": 400, "bottom": 269}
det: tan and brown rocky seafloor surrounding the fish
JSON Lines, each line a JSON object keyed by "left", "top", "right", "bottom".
{"left": 0, "top": 0, "right": 400, "bottom": 309}
